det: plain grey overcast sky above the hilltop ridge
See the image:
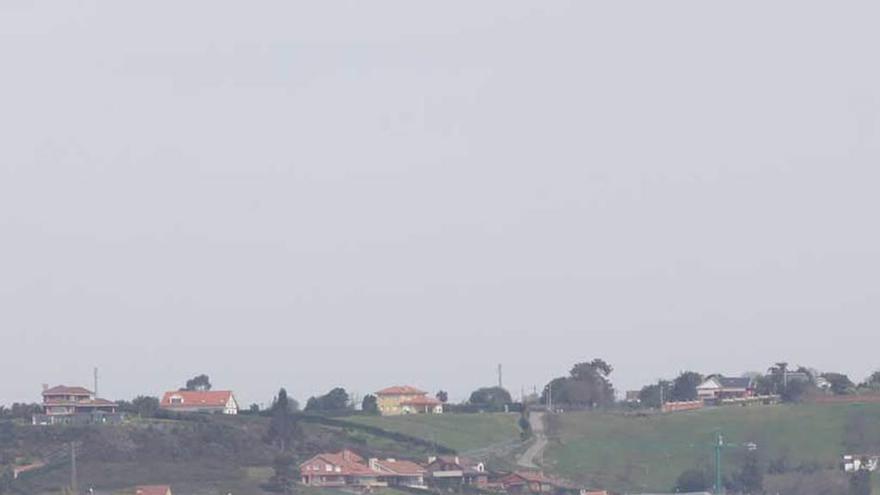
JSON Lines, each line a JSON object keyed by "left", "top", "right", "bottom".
{"left": 0, "top": 0, "right": 880, "bottom": 403}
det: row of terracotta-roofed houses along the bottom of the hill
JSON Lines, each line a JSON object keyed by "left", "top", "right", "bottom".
{"left": 299, "top": 450, "right": 605, "bottom": 495}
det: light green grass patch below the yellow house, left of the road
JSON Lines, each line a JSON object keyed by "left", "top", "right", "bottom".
{"left": 347, "top": 414, "right": 520, "bottom": 452}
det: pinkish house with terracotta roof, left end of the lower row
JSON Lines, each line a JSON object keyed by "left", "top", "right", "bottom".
{"left": 299, "top": 449, "right": 388, "bottom": 488}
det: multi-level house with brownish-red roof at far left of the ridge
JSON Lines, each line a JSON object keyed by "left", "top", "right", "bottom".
{"left": 33, "top": 385, "right": 122, "bottom": 425}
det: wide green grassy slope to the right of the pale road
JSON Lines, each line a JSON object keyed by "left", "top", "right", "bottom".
{"left": 545, "top": 404, "right": 880, "bottom": 490}
